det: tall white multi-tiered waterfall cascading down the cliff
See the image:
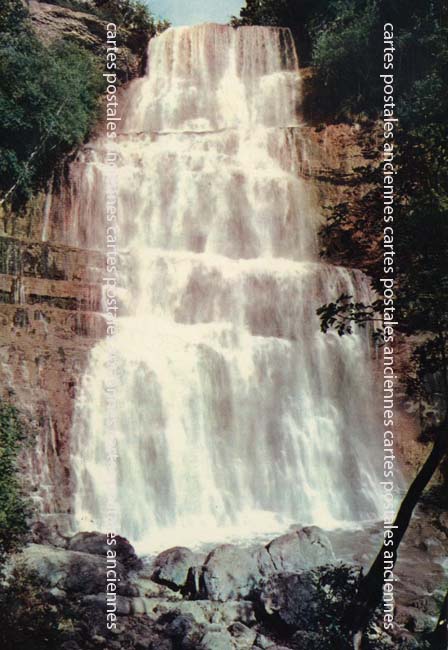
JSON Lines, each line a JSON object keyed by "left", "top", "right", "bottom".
{"left": 72, "top": 25, "right": 379, "bottom": 549}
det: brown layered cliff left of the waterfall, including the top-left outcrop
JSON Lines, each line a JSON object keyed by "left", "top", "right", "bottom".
{"left": 0, "top": 0, "right": 149, "bottom": 515}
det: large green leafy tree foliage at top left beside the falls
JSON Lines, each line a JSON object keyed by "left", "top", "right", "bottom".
{"left": 0, "top": 0, "right": 103, "bottom": 207}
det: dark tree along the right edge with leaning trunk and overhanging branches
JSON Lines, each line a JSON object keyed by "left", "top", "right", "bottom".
{"left": 318, "top": 3, "right": 448, "bottom": 647}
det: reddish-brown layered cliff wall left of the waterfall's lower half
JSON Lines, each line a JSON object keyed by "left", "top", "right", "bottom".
{"left": 0, "top": 237, "right": 105, "bottom": 513}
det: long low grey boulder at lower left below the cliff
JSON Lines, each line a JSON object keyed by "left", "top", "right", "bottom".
{"left": 16, "top": 544, "right": 137, "bottom": 596}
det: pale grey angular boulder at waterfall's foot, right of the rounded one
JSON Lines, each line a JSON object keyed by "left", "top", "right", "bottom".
{"left": 266, "top": 526, "right": 335, "bottom": 573}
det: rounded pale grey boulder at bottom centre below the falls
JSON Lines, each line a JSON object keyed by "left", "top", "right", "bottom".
{"left": 199, "top": 544, "right": 262, "bottom": 602}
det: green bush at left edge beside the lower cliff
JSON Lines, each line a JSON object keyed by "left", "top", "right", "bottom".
{"left": 0, "top": 402, "right": 29, "bottom": 563}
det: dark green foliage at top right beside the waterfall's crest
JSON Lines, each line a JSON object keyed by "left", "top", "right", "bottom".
{"left": 232, "top": 0, "right": 446, "bottom": 119}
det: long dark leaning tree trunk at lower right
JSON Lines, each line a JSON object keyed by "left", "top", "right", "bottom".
{"left": 349, "top": 421, "right": 448, "bottom": 649}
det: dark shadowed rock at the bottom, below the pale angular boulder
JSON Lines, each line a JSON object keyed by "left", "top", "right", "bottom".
{"left": 258, "top": 573, "right": 319, "bottom": 631}
